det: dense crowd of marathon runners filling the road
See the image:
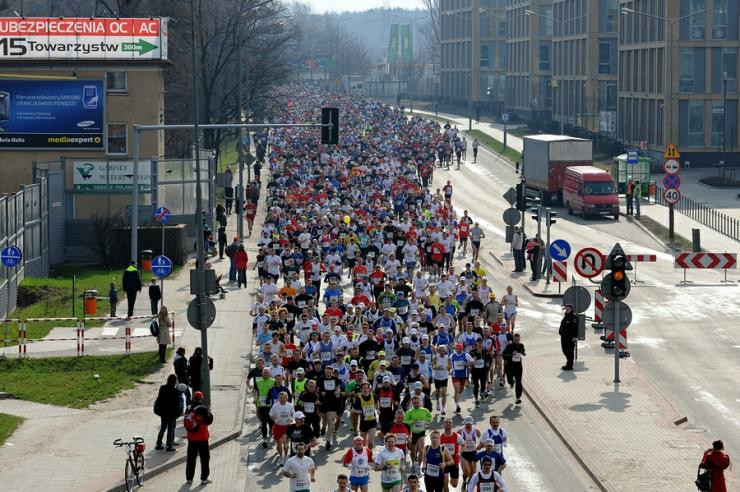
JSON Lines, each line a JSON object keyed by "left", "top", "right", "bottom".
{"left": 248, "top": 88, "right": 526, "bottom": 492}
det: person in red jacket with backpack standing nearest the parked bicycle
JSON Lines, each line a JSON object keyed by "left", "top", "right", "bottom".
{"left": 183, "top": 391, "right": 213, "bottom": 485}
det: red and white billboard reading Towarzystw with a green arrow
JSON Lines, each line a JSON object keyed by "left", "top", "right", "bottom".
{"left": 0, "top": 17, "right": 167, "bottom": 61}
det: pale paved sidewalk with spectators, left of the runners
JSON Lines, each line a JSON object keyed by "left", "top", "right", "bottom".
{"left": 0, "top": 186, "right": 264, "bottom": 491}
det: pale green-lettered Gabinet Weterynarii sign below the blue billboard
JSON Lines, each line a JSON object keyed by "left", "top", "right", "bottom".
{"left": 72, "top": 159, "right": 152, "bottom": 191}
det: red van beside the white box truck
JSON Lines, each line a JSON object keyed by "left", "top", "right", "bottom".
{"left": 563, "top": 166, "right": 619, "bottom": 220}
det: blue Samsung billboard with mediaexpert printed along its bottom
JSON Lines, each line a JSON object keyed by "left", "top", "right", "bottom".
{"left": 0, "top": 79, "right": 105, "bottom": 149}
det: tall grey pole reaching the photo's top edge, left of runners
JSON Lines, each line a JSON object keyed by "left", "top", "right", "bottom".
{"left": 190, "top": 0, "right": 211, "bottom": 404}
